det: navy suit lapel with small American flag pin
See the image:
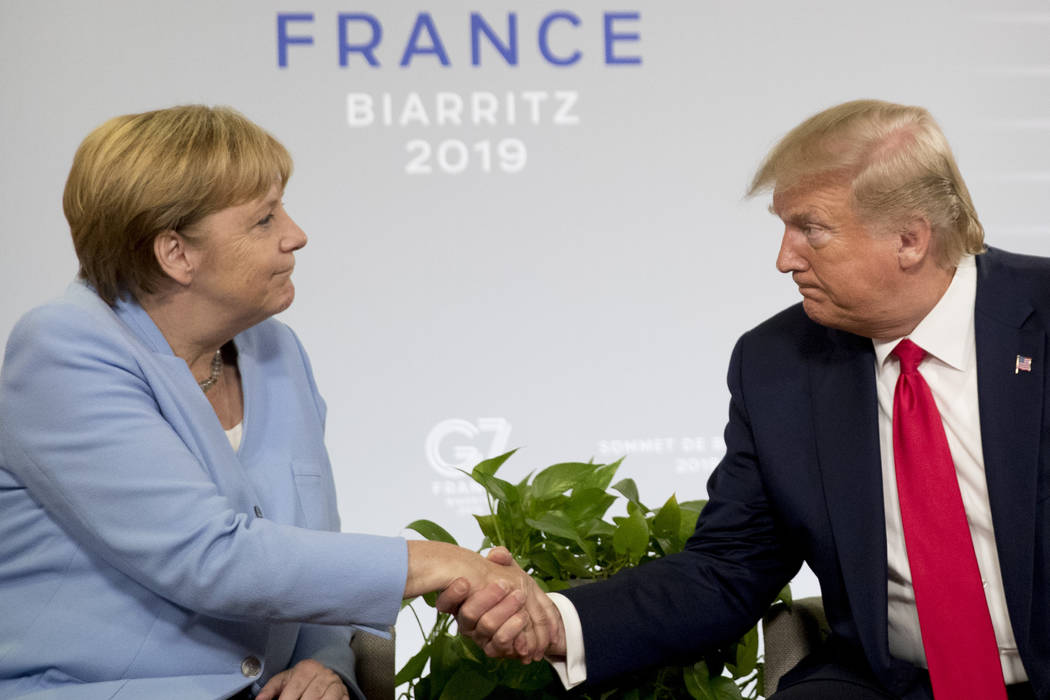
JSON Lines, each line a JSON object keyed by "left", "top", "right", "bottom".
{"left": 974, "top": 251, "right": 1046, "bottom": 640}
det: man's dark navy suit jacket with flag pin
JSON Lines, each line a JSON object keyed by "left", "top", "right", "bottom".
{"left": 565, "top": 250, "right": 1050, "bottom": 698}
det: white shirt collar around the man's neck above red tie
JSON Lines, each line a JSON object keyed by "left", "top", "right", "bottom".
{"left": 872, "top": 255, "right": 978, "bottom": 372}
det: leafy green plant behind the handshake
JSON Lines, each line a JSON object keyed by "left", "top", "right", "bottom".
{"left": 395, "top": 451, "right": 791, "bottom": 700}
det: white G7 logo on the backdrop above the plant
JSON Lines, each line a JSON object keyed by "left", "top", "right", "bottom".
{"left": 425, "top": 418, "right": 510, "bottom": 479}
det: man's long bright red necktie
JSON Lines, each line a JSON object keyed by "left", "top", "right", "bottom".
{"left": 894, "top": 339, "right": 1006, "bottom": 700}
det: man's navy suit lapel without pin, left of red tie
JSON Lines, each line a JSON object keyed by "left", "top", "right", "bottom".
{"left": 810, "top": 331, "right": 890, "bottom": 667}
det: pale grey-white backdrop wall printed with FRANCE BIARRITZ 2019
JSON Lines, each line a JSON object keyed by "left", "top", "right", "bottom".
{"left": 0, "top": 0, "right": 1050, "bottom": 671}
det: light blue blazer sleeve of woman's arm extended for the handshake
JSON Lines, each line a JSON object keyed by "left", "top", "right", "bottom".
{"left": 0, "top": 304, "right": 407, "bottom": 627}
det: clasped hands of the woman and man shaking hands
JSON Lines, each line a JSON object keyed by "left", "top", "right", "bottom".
{"left": 404, "top": 539, "right": 565, "bottom": 663}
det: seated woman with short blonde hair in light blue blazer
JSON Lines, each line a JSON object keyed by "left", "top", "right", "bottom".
{"left": 0, "top": 106, "right": 550, "bottom": 700}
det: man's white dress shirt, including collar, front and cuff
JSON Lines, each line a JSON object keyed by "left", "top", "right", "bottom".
{"left": 550, "top": 257, "right": 1028, "bottom": 688}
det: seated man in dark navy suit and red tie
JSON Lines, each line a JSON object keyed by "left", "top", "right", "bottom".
{"left": 441, "top": 100, "right": 1050, "bottom": 700}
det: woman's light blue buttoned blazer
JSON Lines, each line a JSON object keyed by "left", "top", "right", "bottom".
{"left": 0, "top": 282, "right": 407, "bottom": 700}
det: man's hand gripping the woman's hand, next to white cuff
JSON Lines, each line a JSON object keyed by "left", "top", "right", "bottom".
{"left": 437, "top": 547, "right": 565, "bottom": 663}
